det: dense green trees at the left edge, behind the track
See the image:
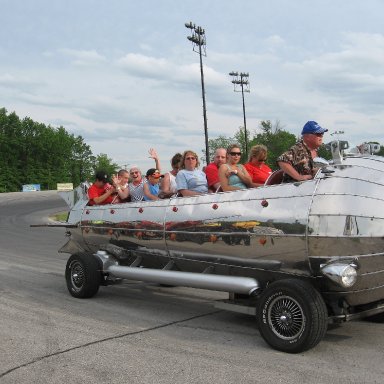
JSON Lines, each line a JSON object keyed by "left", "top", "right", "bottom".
{"left": 0, "top": 108, "right": 117, "bottom": 192}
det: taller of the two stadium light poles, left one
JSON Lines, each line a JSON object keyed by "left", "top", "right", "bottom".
{"left": 185, "top": 21, "right": 209, "bottom": 164}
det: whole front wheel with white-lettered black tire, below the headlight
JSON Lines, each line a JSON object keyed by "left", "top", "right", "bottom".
{"left": 256, "top": 279, "right": 328, "bottom": 353}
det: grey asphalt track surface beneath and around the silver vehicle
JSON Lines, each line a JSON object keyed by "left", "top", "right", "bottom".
{"left": 0, "top": 191, "right": 384, "bottom": 384}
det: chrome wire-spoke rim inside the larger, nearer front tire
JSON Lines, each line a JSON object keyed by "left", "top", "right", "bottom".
{"left": 267, "top": 296, "right": 305, "bottom": 340}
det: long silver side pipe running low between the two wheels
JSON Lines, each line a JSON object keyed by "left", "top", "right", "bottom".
{"left": 104, "top": 265, "right": 260, "bottom": 295}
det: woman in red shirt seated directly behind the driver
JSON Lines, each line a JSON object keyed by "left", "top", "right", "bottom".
{"left": 244, "top": 145, "right": 272, "bottom": 187}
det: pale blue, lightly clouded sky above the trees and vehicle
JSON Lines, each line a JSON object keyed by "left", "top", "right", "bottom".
{"left": 0, "top": 0, "right": 384, "bottom": 172}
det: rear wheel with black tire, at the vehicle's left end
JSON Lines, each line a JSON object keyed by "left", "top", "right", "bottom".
{"left": 65, "top": 253, "right": 102, "bottom": 299}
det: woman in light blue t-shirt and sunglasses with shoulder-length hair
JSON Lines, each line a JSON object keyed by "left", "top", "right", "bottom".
{"left": 176, "top": 150, "right": 208, "bottom": 197}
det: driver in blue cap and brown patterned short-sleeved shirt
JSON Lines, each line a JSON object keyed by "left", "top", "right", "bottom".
{"left": 277, "top": 121, "right": 328, "bottom": 183}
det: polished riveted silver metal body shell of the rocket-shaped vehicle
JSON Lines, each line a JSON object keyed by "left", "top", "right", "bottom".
{"left": 61, "top": 147, "right": 384, "bottom": 315}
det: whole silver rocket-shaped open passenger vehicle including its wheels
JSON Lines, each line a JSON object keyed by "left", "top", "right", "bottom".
{"left": 49, "top": 141, "right": 384, "bottom": 353}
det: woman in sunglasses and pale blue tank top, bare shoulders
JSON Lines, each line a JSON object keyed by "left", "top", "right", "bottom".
{"left": 219, "top": 144, "right": 252, "bottom": 192}
